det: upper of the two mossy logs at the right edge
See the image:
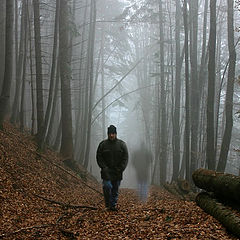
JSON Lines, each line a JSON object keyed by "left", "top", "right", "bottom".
{"left": 192, "top": 168, "right": 240, "bottom": 204}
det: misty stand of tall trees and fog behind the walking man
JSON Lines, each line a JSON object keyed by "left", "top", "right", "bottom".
{"left": 0, "top": 0, "right": 240, "bottom": 186}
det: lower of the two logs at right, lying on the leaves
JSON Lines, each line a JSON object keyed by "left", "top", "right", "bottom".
{"left": 196, "top": 192, "right": 240, "bottom": 238}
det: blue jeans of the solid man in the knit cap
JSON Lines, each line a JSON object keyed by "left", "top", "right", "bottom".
{"left": 102, "top": 180, "right": 121, "bottom": 207}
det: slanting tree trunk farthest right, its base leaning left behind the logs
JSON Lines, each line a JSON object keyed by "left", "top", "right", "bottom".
{"left": 217, "top": 0, "right": 236, "bottom": 172}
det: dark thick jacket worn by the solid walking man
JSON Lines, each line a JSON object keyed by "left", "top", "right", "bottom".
{"left": 96, "top": 139, "right": 128, "bottom": 181}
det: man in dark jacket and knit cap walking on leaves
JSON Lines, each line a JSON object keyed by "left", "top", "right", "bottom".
{"left": 96, "top": 125, "right": 128, "bottom": 211}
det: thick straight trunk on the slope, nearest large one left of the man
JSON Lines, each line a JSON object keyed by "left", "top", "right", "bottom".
{"left": 59, "top": 0, "right": 73, "bottom": 161}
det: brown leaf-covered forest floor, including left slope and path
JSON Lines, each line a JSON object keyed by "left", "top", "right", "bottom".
{"left": 0, "top": 124, "right": 237, "bottom": 240}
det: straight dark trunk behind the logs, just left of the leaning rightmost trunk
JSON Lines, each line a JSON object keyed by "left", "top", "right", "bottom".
{"left": 206, "top": 0, "right": 216, "bottom": 170}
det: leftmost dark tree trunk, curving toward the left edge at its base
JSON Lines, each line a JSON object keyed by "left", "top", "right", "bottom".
{"left": 0, "top": 0, "right": 14, "bottom": 129}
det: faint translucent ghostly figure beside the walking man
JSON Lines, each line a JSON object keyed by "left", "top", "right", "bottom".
{"left": 132, "top": 142, "right": 152, "bottom": 202}
